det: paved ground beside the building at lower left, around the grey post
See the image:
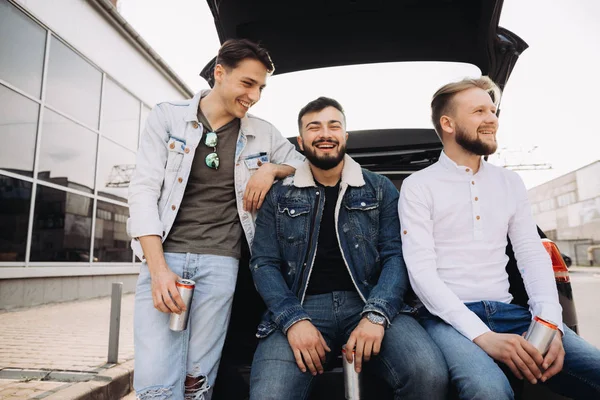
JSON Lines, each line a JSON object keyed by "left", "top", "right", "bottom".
{"left": 0, "top": 294, "right": 134, "bottom": 400}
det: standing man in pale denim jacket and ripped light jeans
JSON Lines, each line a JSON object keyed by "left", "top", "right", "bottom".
{"left": 127, "top": 40, "right": 304, "bottom": 400}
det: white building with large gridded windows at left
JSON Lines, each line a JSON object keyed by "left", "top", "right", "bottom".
{"left": 0, "top": 0, "right": 193, "bottom": 309}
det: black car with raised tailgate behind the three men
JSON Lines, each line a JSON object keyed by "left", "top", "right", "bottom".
{"left": 201, "top": 0, "right": 577, "bottom": 400}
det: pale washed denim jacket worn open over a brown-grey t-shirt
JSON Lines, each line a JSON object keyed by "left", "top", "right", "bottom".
{"left": 127, "top": 91, "right": 304, "bottom": 259}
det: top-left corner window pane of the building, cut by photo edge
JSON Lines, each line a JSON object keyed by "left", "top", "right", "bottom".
{"left": 0, "top": 0, "right": 46, "bottom": 98}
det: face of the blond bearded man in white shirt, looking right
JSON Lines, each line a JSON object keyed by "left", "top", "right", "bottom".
{"left": 442, "top": 88, "right": 498, "bottom": 156}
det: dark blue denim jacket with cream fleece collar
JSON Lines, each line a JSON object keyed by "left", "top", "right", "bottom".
{"left": 250, "top": 155, "right": 409, "bottom": 338}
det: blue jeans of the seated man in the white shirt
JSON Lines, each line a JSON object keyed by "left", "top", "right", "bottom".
{"left": 419, "top": 301, "right": 600, "bottom": 400}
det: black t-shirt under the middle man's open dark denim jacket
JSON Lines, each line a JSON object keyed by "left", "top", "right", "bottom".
{"left": 306, "top": 182, "right": 356, "bottom": 294}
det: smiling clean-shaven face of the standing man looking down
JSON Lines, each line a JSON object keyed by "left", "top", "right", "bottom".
{"left": 214, "top": 58, "right": 268, "bottom": 118}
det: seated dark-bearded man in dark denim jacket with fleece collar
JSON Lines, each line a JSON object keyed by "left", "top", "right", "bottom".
{"left": 250, "top": 97, "right": 448, "bottom": 400}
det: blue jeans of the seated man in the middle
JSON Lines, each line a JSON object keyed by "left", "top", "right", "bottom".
{"left": 250, "top": 292, "right": 448, "bottom": 400}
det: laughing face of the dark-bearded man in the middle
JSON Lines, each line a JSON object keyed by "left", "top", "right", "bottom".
{"left": 298, "top": 106, "right": 348, "bottom": 170}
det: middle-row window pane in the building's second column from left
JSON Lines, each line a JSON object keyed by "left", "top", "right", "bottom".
{"left": 38, "top": 109, "right": 98, "bottom": 193}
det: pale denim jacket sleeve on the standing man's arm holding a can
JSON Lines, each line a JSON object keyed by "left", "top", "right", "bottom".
{"left": 127, "top": 104, "right": 169, "bottom": 238}
